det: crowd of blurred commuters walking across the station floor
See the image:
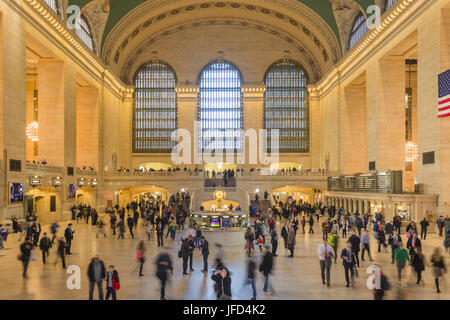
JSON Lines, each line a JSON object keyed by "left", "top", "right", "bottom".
{"left": 4, "top": 192, "right": 450, "bottom": 300}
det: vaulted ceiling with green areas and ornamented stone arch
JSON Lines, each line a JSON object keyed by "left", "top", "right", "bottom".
{"left": 69, "top": 0, "right": 376, "bottom": 83}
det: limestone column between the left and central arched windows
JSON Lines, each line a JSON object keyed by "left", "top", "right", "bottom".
{"left": 175, "top": 85, "right": 199, "bottom": 169}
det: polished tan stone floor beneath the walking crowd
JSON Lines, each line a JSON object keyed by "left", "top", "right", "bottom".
{"left": 0, "top": 218, "right": 450, "bottom": 300}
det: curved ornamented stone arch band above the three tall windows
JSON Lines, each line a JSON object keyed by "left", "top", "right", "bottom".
{"left": 102, "top": 0, "right": 341, "bottom": 82}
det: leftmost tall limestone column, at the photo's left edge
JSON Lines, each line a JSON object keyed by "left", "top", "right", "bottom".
{"left": 0, "top": 10, "right": 29, "bottom": 220}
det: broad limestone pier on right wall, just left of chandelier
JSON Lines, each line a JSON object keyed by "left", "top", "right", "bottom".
{"left": 366, "top": 56, "right": 405, "bottom": 171}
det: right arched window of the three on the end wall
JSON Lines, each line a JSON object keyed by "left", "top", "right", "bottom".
{"left": 264, "top": 59, "right": 309, "bottom": 152}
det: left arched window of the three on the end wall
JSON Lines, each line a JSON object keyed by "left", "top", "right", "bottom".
{"left": 133, "top": 61, "right": 177, "bottom": 153}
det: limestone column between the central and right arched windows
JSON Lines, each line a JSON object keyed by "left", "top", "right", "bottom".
{"left": 241, "top": 84, "right": 266, "bottom": 169}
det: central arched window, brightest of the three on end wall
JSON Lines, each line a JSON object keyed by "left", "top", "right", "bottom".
{"left": 198, "top": 61, "right": 244, "bottom": 151}
